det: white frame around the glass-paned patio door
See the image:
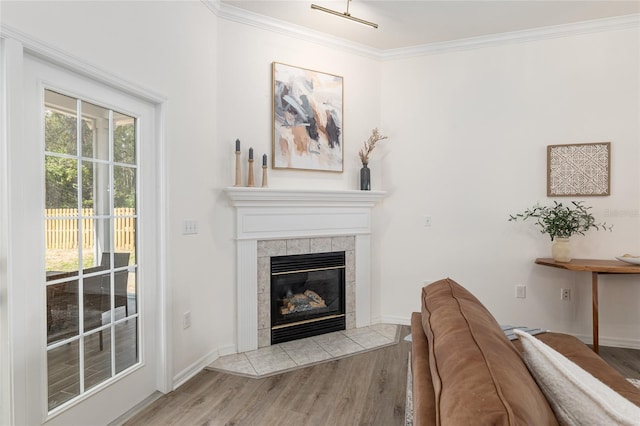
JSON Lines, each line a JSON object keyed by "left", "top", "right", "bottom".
{"left": 0, "top": 26, "right": 173, "bottom": 424}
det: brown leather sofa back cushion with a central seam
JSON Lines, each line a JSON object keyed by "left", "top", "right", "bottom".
{"left": 422, "top": 279, "right": 557, "bottom": 425}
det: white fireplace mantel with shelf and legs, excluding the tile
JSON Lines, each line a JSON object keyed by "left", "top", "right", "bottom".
{"left": 226, "top": 187, "right": 385, "bottom": 352}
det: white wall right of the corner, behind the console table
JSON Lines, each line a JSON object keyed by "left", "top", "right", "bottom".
{"left": 374, "top": 29, "right": 640, "bottom": 347}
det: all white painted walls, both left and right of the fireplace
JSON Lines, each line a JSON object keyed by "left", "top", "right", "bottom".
{"left": 2, "top": 2, "right": 640, "bottom": 412}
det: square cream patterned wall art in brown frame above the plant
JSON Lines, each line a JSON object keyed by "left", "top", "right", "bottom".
{"left": 547, "top": 142, "right": 611, "bottom": 197}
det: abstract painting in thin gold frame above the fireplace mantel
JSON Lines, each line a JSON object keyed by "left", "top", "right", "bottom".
{"left": 271, "top": 62, "right": 344, "bottom": 173}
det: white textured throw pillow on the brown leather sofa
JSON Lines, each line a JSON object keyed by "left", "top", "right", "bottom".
{"left": 515, "top": 330, "right": 640, "bottom": 426}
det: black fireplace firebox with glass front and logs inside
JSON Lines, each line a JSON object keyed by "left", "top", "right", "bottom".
{"left": 271, "top": 251, "right": 346, "bottom": 344}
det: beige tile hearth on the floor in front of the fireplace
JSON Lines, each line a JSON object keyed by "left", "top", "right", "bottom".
{"left": 206, "top": 324, "right": 399, "bottom": 378}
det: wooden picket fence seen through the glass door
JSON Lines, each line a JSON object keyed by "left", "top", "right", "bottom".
{"left": 45, "top": 208, "right": 136, "bottom": 252}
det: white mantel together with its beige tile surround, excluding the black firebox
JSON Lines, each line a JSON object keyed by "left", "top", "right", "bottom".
{"left": 226, "top": 187, "right": 384, "bottom": 352}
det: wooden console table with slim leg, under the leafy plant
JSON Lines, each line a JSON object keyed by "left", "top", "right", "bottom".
{"left": 536, "top": 258, "right": 640, "bottom": 353}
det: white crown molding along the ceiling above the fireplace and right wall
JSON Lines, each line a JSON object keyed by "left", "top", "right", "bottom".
{"left": 202, "top": 0, "right": 640, "bottom": 60}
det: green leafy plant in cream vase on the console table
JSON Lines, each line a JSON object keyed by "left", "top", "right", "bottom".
{"left": 509, "top": 201, "right": 613, "bottom": 262}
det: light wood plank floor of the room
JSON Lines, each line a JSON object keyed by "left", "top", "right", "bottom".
{"left": 125, "top": 326, "right": 640, "bottom": 426}
